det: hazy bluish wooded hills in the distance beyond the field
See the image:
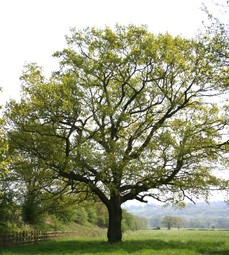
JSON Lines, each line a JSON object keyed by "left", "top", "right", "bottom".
{"left": 126, "top": 201, "right": 229, "bottom": 229}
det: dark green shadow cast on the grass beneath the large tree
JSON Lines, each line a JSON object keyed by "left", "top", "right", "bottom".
{"left": 0, "top": 239, "right": 229, "bottom": 255}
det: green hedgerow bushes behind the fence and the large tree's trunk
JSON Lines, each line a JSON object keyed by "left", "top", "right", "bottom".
{"left": 0, "top": 182, "right": 148, "bottom": 232}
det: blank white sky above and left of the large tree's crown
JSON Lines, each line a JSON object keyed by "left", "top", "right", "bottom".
{"left": 0, "top": 0, "right": 214, "bottom": 104}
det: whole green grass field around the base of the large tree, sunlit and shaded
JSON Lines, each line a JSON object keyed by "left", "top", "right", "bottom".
{"left": 0, "top": 230, "right": 229, "bottom": 255}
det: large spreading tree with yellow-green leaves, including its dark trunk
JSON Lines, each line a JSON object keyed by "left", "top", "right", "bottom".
{"left": 6, "top": 25, "right": 228, "bottom": 242}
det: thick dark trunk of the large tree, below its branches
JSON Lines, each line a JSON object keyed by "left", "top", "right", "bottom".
{"left": 107, "top": 196, "right": 122, "bottom": 243}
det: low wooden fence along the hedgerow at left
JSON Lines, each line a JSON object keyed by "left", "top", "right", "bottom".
{"left": 0, "top": 231, "right": 77, "bottom": 248}
